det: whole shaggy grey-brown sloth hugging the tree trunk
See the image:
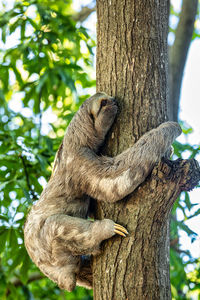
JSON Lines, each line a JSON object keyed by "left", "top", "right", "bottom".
{"left": 24, "top": 93, "right": 181, "bottom": 291}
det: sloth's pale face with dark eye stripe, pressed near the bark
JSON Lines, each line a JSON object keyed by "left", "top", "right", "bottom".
{"left": 89, "top": 93, "right": 117, "bottom": 136}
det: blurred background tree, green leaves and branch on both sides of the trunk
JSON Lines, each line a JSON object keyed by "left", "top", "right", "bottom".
{"left": 0, "top": 0, "right": 200, "bottom": 300}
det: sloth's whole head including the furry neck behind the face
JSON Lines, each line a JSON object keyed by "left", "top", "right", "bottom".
{"left": 66, "top": 93, "right": 117, "bottom": 151}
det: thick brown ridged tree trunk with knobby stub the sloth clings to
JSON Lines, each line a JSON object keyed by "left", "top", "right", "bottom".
{"left": 93, "top": 0, "right": 199, "bottom": 300}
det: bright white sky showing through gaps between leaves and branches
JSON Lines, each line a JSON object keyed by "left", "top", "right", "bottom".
{"left": 0, "top": 0, "right": 200, "bottom": 257}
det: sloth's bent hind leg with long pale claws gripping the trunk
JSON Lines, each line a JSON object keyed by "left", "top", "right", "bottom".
{"left": 43, "top": 215, "right": 128, "bottom": 255}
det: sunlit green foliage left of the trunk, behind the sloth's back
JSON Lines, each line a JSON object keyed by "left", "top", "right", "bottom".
{"left": 0, "top": 0, "right": 94, "bottom": 299}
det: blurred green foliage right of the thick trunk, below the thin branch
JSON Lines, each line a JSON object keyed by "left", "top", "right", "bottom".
{"left": 170, "top": 123, "right": 200, "bottom": 299}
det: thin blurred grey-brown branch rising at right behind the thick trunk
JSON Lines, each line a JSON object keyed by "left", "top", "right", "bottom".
{"left": 168, "top": 0, "right": 198, "bottom": 121}
